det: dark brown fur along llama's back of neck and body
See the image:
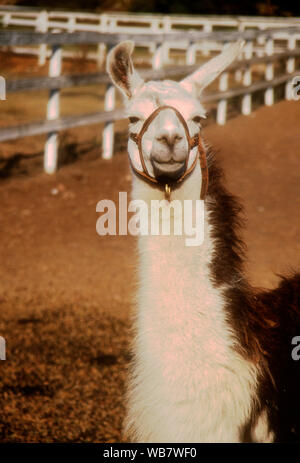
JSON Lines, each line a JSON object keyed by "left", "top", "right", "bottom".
{"left": 206, "top": 148, "right": 300, "bottom": 442}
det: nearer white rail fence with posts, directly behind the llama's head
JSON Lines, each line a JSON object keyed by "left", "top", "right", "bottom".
{"left": 0, "top": 26, "right": 300, "bottom": 173}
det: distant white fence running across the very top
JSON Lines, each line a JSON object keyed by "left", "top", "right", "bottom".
{"left": 0, "top": 6, "right": 300, "bottom": 34}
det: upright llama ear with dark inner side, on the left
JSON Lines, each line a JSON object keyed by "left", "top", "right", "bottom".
{"left": 106, "top": 40, "right": 144, "bottom": 98}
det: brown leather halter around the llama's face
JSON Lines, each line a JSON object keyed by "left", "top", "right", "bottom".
{"left": 129, "top": 106, "right": 208, "bottom": 199}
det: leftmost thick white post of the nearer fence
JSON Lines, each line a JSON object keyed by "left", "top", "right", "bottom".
{"left": 44, "top": 45, "right": 62, "bottom": 174}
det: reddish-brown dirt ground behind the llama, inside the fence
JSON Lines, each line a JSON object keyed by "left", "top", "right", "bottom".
{"left": 0, "top": 102, "right": 300, "bottom": 442}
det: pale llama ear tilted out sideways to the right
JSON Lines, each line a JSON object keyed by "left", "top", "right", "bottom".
{"left": 180, "top": 40, "right": 244, "bottom": 95}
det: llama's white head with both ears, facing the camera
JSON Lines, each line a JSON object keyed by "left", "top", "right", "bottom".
{"left": 107, "top": 41, "right": 242, "bottom": 188}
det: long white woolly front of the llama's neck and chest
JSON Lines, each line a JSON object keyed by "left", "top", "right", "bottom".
{"left": 127, "top": 160, "right": 256, "bottom": 442}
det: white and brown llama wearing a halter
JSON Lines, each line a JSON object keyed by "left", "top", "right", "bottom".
{"left": 107, "top": 41, "right": 300, "bottom": 443}
